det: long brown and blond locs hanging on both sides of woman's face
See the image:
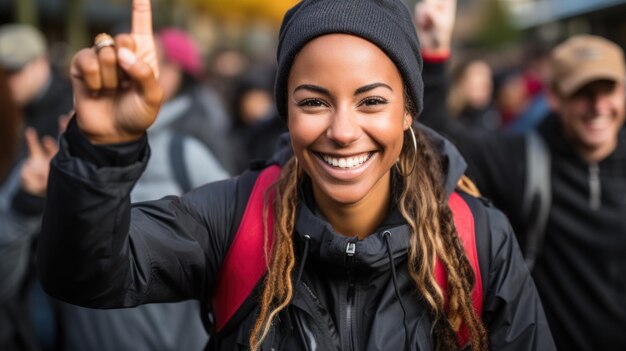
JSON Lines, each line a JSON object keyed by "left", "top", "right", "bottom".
{"left": 250, "top": 105, "right": 488, "bottom": 350}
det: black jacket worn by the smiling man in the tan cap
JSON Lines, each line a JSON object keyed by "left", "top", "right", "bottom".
{"left": 422, "top": 63, "right": 626, "bottom": 350}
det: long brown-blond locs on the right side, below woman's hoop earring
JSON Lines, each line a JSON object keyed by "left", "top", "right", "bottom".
{"left": 399, "top": 126, "right": 487, "bottom": 350}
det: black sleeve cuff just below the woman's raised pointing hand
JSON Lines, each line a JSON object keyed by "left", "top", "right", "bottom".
{"left": 64, "top": 118, "right": 148, "bottom": 168}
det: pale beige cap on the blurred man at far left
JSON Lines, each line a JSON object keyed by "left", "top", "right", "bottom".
{"left": 0, "top": 24, "right": 46, "bottom": 70}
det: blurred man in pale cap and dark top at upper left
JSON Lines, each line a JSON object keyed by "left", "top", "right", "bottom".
{"left": 0, "top": 24, "right": 72, "bottom": 138}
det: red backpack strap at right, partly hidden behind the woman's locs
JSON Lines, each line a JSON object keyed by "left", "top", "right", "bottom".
{"left": 435, "top": 192, "right": 483, "bottom": 346}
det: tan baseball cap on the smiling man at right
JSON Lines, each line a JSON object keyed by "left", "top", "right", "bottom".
{"left": 550, "top": 35, "right": 626, "bottom": 96}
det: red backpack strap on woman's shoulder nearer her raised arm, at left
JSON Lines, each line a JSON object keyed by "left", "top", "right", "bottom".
{"left": 213, "top": 165, "right": 280, "bottom": 332}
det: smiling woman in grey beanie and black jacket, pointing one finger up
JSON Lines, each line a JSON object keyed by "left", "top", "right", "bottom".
{"left": 39, "top": 0, "right": 553, "bottom": 350}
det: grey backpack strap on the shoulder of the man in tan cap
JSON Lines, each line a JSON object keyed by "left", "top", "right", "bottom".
{"left": 522, "top": 131, "right": 552, "bottom": 270}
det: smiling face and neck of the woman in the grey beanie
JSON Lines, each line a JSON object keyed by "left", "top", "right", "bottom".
{"left": 287, "top": 34, "right": 404, "bottom": 216}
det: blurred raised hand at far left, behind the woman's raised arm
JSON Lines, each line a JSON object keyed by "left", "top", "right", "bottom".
{"left": 20, "top": 128, "right": 58, "bottom": 197}
